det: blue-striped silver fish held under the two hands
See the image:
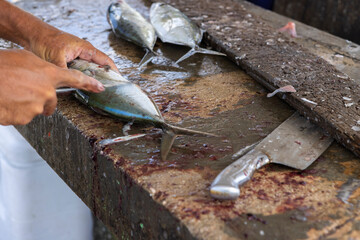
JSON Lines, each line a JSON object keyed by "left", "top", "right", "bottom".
{"left": 69, "top": 60, "right": 216, "bottom": 160}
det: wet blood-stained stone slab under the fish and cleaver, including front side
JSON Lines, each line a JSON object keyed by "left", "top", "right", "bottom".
{"left": 0, "top": 0, "right": 360, "bottom": 239}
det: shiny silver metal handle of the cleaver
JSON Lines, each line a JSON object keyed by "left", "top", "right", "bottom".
{"left": 210, "top": 149, "right": 270, "bottom": 200}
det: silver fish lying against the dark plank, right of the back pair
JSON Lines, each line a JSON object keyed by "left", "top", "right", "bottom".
{"left": 150, "top": 2, "right": 226, "bottom": 63}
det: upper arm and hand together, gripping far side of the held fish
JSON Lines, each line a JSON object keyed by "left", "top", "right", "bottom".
{"left": 0, "top": 0, "right": 118, "bottom": 71}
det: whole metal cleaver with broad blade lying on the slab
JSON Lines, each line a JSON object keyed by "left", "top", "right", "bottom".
{"left": 210, "top": 112, "right": 333, "bottom": 200}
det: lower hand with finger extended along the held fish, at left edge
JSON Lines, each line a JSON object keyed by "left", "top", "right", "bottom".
{"left": 0, "top": 50, "right": 104, "bottom": 125}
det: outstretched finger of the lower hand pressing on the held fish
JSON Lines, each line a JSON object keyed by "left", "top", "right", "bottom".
{"left": 55, "top": 69, "right": 105, "bottom": 93}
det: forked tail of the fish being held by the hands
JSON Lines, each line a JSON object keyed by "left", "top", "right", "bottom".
{"left": 160, "top": 124, "right": 218, "bottom": 161}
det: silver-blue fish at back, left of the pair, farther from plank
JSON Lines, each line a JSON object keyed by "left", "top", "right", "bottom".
{"left": 107, "top": 0, "right": 157, "bottom": 67}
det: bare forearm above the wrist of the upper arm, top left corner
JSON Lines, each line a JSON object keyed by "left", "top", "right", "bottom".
{"left": 0, "top": 0, "right": 61, "bottom": 50}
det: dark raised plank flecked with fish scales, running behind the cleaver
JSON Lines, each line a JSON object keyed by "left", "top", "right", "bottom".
{"left": 154, "top": 0, "right": 360, "bottom": 156}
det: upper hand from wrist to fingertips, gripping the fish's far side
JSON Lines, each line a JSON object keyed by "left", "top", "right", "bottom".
{"left": 29, "top": 28, "right": 118, "bottom": 72}
